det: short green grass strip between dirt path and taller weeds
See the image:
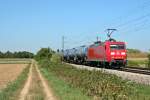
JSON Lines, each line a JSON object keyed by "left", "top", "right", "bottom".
{"left": 40, "top": 68, "right": 90, "bottom": 100}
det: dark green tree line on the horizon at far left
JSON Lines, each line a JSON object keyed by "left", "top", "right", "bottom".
{"left": 0, "top": 51, "right": 34, "bottom": 58}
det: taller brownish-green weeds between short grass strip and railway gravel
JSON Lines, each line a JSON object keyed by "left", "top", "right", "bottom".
{"left": 40, "top": 62, "right": 141, "bottom": 100}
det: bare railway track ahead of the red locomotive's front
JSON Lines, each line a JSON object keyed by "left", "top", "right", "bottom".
{"left": 120, "top": 67, "right": 150, "bottom": 75}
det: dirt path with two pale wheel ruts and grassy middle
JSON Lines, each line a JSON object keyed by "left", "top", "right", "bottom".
{"left": 19, "top": 61, "right": 56, "bottom": 100}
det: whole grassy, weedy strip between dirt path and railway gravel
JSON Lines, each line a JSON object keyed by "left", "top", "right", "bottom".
{"left": 37, "top": 61, "right": 150, "bottom": 100}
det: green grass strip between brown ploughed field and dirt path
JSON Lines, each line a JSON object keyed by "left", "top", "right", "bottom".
{"left": 0, "top": 65, "right": 30, "bottom": 100}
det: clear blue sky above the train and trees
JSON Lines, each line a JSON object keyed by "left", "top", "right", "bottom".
{"left": 0, "top": 0, "right": 150, "bottom": 52}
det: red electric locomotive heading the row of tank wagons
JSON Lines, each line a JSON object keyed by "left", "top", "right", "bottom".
{"left": 87, "top": 40, "right": 127, "bottom": 67}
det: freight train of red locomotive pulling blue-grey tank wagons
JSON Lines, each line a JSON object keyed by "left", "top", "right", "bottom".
{"left": 63, "top": 28, "right": 127, "bottom": 68}
